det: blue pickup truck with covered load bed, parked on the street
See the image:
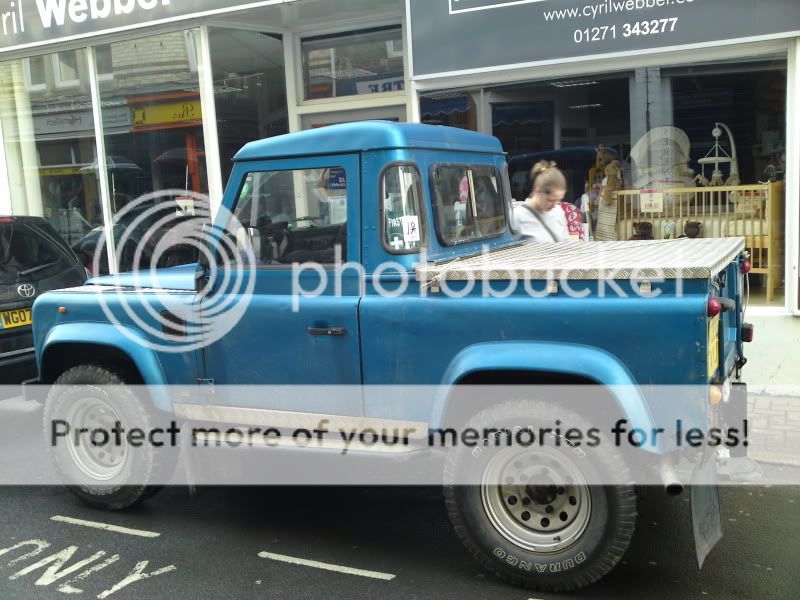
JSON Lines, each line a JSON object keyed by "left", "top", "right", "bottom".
{"left": 33, "top": 122, "right": 752, "bottom": 591}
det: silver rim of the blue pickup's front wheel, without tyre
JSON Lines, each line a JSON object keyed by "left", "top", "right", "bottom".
{"left": 65, "top": 397, "right": 128, "bottom": 481}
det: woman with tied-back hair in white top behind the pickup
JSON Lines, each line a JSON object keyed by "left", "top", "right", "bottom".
{"left": 514, "top": 161, "right": 569, "bottom": 242}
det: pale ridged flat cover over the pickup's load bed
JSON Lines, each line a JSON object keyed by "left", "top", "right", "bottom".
{"left": 416, "top": 237, "right": 745, "bottom": 281}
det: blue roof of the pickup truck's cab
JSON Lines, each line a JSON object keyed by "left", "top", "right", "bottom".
{"left": 233, "top": 121, "right": 503, "bottom": 161}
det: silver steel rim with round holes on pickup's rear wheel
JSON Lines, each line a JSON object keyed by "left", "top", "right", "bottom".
{"left": 481, "top": 448, "right": 591, "bottom": 554}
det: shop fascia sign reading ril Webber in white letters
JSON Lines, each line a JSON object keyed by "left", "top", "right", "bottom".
{"left": 0, "top": 0, "right": 294, "bottom": 52}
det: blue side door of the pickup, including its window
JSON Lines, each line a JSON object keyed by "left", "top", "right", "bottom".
{"left": 201, "top": 155, "right": 362, "bottom": 415}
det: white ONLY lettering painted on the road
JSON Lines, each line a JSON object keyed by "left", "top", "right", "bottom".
{"left": 0, "top": 539, "right": 177, "bottom": 600}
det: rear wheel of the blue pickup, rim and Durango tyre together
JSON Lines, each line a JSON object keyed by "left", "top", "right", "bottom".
{"left": 445, "top": 400, "right": 636, "bottom": 592}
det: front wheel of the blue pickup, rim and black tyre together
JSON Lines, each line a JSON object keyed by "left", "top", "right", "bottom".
{"left": 43, "top": 365, "right": 175, "bottom": 510}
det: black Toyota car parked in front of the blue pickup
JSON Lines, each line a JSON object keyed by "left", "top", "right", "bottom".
{"left": 0, "top": 217, "right": 86, "bottom": 385}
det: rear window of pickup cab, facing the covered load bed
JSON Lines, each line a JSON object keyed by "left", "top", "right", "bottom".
{"left": 432, "top": 165, "right": 506, "bottom": 246}
